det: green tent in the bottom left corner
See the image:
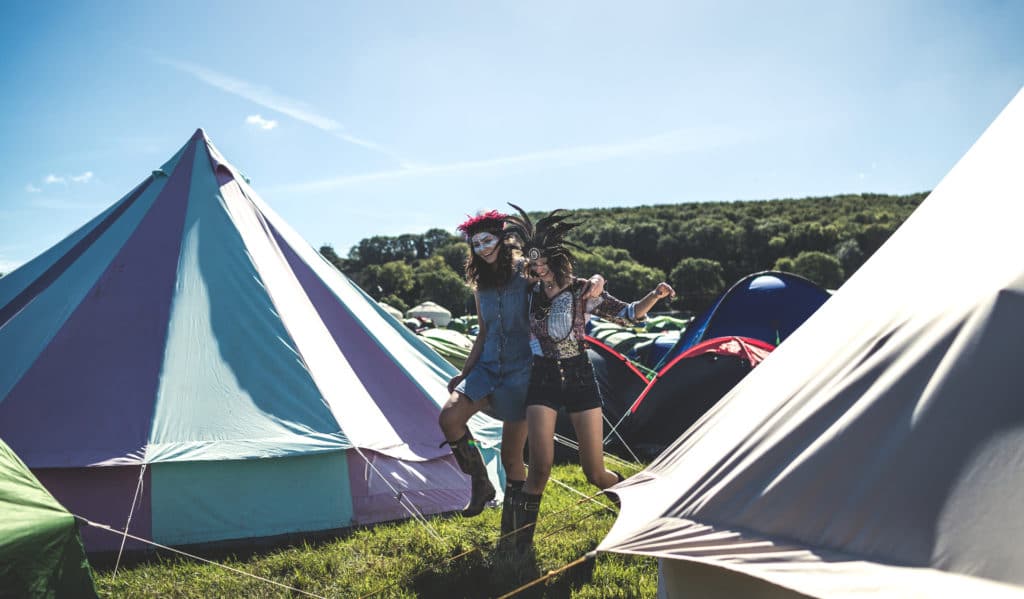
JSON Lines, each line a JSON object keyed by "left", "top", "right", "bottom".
{"left": 0, "top": 440, "right": 96, "bottom": 597}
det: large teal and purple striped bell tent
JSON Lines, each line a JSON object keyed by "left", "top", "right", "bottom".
{"left": 0, "top": 130, "right": 504, "bottom": 552}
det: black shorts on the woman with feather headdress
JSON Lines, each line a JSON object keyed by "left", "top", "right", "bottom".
{"left": 526, "top": 353, "right": 601, "bottom": 414}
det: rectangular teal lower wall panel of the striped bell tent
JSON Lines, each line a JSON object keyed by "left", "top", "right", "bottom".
{"left": 152, "top": 452, "right": 352, "bottom": 545}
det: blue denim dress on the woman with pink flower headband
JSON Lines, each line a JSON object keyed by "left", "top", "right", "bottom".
{"left": 456, "top": 264, "right": 532, "bottom": 422}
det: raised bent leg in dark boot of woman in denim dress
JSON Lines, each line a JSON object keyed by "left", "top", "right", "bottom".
{"left": 437, "top": 392, "right": 496, "bottom": 518}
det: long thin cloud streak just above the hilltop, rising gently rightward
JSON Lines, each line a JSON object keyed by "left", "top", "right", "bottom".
{"left": 275, "top": 127, "right": 746, "bottom": 191}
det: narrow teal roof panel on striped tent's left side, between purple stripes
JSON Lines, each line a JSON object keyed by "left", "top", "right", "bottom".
{"left": 0, "top": 164, "right": 178, "bottom": 400}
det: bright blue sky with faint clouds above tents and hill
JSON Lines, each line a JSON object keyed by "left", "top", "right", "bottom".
{"left": 0, "top": 0, "right": 1024, "bottom": 271}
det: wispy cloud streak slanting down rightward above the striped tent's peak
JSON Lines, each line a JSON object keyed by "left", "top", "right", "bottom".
{"left": 156, "top": 58, "right": 411, "bottom": 166}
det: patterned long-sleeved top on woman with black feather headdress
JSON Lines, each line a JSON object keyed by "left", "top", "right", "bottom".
{"left": 529, "top": 279, "right": 636, "bottom": 359}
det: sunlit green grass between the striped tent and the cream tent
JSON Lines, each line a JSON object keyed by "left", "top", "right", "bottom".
{"left": 96, "top": 465, "right": 657, "bottom": 599}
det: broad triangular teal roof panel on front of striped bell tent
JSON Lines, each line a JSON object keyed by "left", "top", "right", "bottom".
{"left": 146, "top": 145, "right": 351, "bottom": 463}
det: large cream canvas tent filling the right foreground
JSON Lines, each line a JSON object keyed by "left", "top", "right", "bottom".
{"left": 598, "top": 87, "right": 1024, "bottom": 597}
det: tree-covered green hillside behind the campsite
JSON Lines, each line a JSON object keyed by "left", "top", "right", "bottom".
{"left": 321, "top": 192, "right": 927, "bottom": 315}
